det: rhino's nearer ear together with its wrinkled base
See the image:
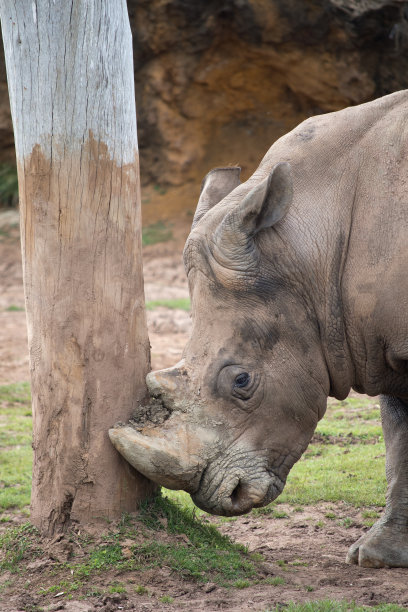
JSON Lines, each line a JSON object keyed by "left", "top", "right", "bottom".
{"left": 215, "top": 162, "right": 293, "bottom": 269}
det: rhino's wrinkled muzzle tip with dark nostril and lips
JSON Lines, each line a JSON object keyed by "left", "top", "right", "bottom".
{"left": 191, "top": 467, "right": 285, "bottom": 516}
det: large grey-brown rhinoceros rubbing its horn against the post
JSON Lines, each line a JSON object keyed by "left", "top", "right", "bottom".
{"left": 110, "top": 91, "right": 408, "bottom": 567}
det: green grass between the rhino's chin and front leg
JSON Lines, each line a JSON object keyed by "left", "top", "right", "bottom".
{"left": 268, "top": 397, "right": 386, "bottom": 506}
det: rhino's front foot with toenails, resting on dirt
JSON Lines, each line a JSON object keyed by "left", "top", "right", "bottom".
{"left": 346, "top": 519, "right": 408, "bottom": 568}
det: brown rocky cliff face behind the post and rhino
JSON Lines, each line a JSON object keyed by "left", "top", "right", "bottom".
{"left": 0, "top": 0, "right": 408, "bottom": 185}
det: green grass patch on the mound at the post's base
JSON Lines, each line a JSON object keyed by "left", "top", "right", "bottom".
{"left": 36, "top": 497, "right": 257, "bottom": 595}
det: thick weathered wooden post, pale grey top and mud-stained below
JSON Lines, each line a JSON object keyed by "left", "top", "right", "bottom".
{"left": 0, "top": 0, "right": 153, "bottom": 534}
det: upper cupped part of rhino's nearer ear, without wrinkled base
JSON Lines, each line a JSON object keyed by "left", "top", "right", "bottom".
{"left": 235, "top": 162, "right": 293, "bottom": 236}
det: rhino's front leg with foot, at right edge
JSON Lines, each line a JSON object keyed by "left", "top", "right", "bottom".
{"left": 347, "top": 395, "right": 408, "bottom": 567}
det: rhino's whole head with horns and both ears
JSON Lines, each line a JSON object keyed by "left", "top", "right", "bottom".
{"left": 110, "top": 163, "right": 329, "bottom": 515}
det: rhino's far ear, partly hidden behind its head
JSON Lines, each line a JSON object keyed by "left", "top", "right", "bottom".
{"left": 191, "top": 166, "right": 241, "bottom": 229}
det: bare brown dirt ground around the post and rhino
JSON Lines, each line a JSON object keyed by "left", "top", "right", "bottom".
{"left": 0, "top": 211, "right": 408, "bottom": 612}
